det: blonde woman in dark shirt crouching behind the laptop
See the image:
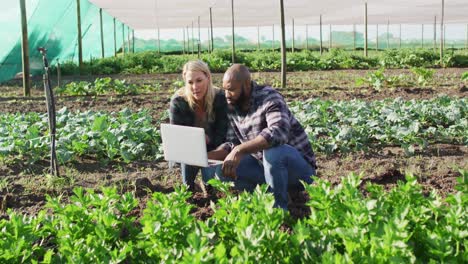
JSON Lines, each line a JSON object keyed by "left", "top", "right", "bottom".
{"left": 169, "top": 60, "right": 228, "bottom": 191}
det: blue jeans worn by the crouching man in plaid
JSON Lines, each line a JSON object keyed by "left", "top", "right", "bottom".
{"left": 219, "top": 144, "right": 316, "bottom": 210}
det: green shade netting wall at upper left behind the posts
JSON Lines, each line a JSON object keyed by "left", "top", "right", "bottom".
{"left": 0, "top": 0, "right": 129, "bottom": 82}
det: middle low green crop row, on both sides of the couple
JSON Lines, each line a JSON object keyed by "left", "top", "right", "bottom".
{"left": 0, "top": 96, "right": 468, "bottom": 163}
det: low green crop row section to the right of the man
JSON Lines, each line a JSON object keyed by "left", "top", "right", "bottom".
{"left": 290, "top": 96, "right": 468, "bottom": 154}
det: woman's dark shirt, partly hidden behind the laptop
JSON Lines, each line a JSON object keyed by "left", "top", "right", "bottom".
{"left": 169, "top": 89, "right": 228, "bottom": 151}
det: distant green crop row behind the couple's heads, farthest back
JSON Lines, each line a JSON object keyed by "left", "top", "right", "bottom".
{"left": 52, "top": 49, "right": 468, "bottom": 75}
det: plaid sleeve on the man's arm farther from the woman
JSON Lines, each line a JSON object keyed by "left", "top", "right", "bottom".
{"left": 260, "top": 94, "right": 291, "bottom": 147}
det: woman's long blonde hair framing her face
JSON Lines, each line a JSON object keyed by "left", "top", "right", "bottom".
{"left": 177, "top": 60, "right": 219, "bottom": 121}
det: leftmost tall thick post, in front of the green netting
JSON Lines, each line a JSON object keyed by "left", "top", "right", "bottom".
{"left": 20, "top": 0, "right": 31, "bottom": 96}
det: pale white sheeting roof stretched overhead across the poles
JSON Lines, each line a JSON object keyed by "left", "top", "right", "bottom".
{"left": 90, "top": 0, "right": 468, "bottom": 29}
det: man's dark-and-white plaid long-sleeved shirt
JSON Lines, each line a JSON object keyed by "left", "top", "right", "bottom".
{"left": 221, "top": 82, "right": 316, "bottom": 167}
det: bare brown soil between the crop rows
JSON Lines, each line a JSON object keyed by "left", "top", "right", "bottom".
{"left": 0, "top": 69, "right": 468, "bottom": 219}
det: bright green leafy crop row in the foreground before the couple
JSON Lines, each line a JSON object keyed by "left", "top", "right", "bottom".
{"left": 0, "top": 171, "right": 468, "bottom": 263}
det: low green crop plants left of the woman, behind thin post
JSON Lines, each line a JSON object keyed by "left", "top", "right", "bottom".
{"left": 0, "top": 108, "right": 161, "bottom": 164}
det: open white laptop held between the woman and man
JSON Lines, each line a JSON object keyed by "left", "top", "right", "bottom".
{"left": 161, "top": 124, "right": 223, "bottom": 167}
